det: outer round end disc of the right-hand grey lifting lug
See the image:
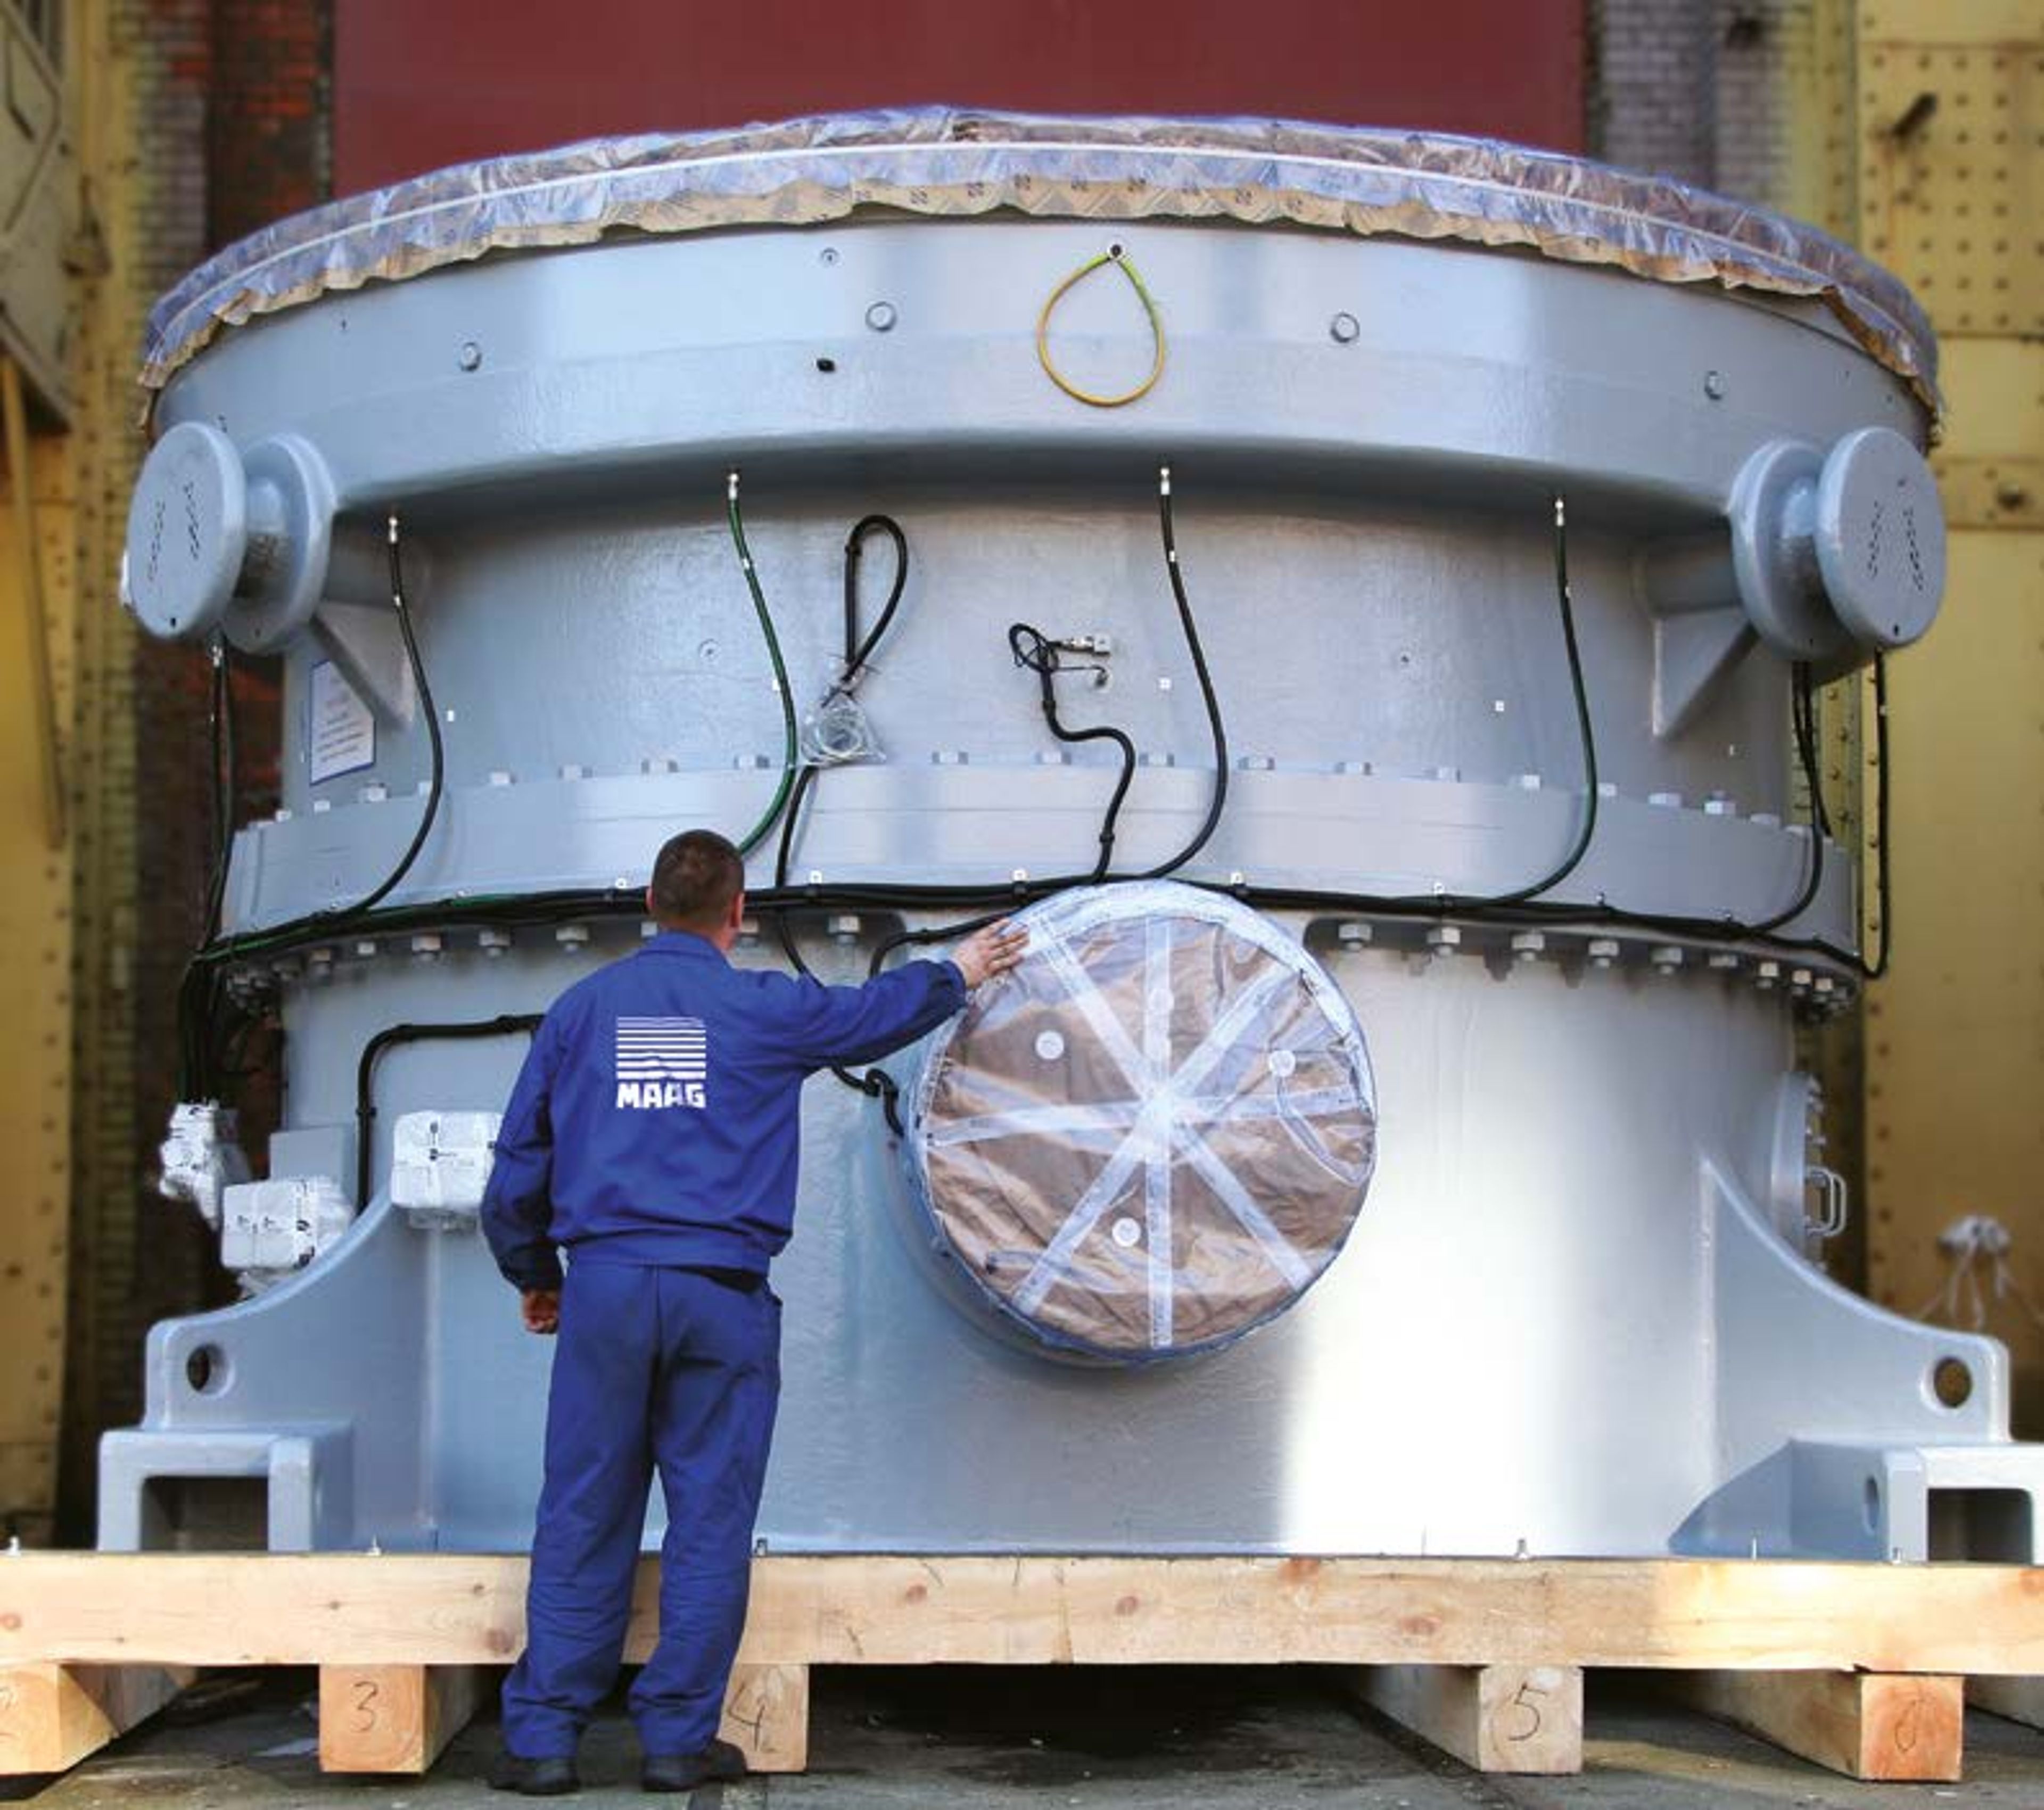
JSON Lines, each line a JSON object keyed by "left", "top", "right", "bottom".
{"left": 1815, "top": 427, "right": 1944, "bottom": 648}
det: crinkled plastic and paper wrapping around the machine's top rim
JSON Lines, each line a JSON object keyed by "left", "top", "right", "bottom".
{"left": 141, "top": 106, "right": 1940, "bottom": 413}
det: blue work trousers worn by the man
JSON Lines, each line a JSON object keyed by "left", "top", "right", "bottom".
{"left": 505, "top": 1258, "right": 781, "bottom": 1759}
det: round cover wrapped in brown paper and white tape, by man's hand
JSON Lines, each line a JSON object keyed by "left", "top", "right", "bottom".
{"left": 910, "top": 882, "right": 1375, "bottom": 1362}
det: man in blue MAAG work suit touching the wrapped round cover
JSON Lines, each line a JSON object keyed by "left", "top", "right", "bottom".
{"left": 482, "top": 830, "right": 1026, "bottom": 1796}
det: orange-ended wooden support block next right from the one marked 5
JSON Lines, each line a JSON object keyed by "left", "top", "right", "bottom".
{"left": 1674, "top": 1671, "right": 1966, "bottom": 1781}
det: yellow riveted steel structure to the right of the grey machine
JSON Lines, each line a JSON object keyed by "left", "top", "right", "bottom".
{"left": 1852, "top": 0, "right": 2044, "bottom": 1438}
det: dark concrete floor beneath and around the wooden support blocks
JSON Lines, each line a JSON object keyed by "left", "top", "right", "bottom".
{"left": 12, "top": 1667, "right": 2044, "bottom": 1810}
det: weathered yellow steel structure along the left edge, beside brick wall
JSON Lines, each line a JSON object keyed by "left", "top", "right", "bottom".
{"left": 0, "top": 4, "right": 145, "bottom": 1540}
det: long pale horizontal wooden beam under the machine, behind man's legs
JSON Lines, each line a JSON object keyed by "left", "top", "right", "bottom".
{"left": 0, "top": 1552, "right": 2044, "bottom": 1673}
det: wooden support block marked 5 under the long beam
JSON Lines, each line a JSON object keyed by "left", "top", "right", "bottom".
{"left": 1357, "top": 1665, "right": 1582, "bottom": 1773}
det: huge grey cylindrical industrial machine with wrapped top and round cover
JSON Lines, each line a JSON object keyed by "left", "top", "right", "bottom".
{"left": 100, "top": 110, "right": 2044, "bottom": 1560}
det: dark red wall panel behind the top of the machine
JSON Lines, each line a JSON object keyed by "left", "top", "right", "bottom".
{"left": 333, "top": 0, "right": 1584, "bottom": 194}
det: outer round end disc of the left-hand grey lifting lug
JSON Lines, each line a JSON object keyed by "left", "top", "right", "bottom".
{"left": 125, "top": 421, "right": 248, "bottom": 640}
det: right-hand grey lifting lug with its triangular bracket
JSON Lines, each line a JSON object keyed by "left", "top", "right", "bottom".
{"left": 1637, "top": 427, "right": 1944, "bottom": 741}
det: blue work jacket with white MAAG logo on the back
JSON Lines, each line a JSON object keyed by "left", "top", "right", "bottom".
{"left": 482, "top": 931, "right": 965, "bottom": 1288}
